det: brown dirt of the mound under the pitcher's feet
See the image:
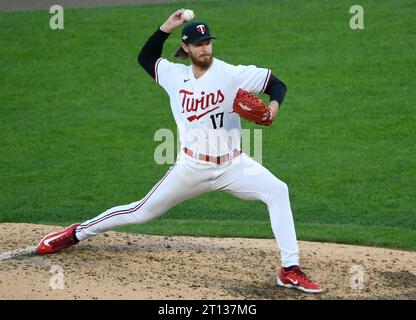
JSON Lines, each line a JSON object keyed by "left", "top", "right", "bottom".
{"left": 0, "top": 224, "right": 416, "bottom": 300}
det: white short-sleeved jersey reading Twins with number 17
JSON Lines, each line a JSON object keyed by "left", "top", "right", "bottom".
{"left": 155, "top": 58, "right": 271, "bottom": 156}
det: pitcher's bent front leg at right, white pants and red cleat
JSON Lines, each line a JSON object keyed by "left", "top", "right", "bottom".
{"left": 214, "top": 153, "right": 321, "bottom": 293}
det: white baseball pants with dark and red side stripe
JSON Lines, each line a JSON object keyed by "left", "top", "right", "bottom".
{"left": 76, "top": 151, "right": 299, "bottom": 267}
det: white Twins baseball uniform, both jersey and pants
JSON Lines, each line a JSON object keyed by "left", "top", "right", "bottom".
{"left": 76, "top": 58, "right": 299, "bottom": 267}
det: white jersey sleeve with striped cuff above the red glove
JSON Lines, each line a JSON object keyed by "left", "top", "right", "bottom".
{"left": 235, "top": 65, "right": 272, "bottom": 93}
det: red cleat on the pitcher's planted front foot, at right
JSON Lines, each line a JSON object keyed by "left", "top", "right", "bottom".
{"left": 277, "top": 266, "right": 322, "bottom": 293}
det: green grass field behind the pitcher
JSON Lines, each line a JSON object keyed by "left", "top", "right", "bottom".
{"left": 0, "top": 0, "right": 416, "bottom": 250}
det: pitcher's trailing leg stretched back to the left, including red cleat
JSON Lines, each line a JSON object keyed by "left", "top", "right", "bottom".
{"left": 38, "top": 154, "right": 212, "bottom": 254}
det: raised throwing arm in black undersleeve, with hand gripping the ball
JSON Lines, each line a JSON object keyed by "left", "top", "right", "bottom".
{"left": 137, "top": 9, "right": 186, "bottom": 78}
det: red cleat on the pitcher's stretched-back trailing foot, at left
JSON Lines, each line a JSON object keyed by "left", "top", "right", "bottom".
{"left": 38, "top": 224, "right": 79, "bottom": 254}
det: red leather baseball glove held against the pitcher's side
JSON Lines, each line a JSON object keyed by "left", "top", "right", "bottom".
{"left": 233, "top": 89, "right": 273, "bottom": 126}
